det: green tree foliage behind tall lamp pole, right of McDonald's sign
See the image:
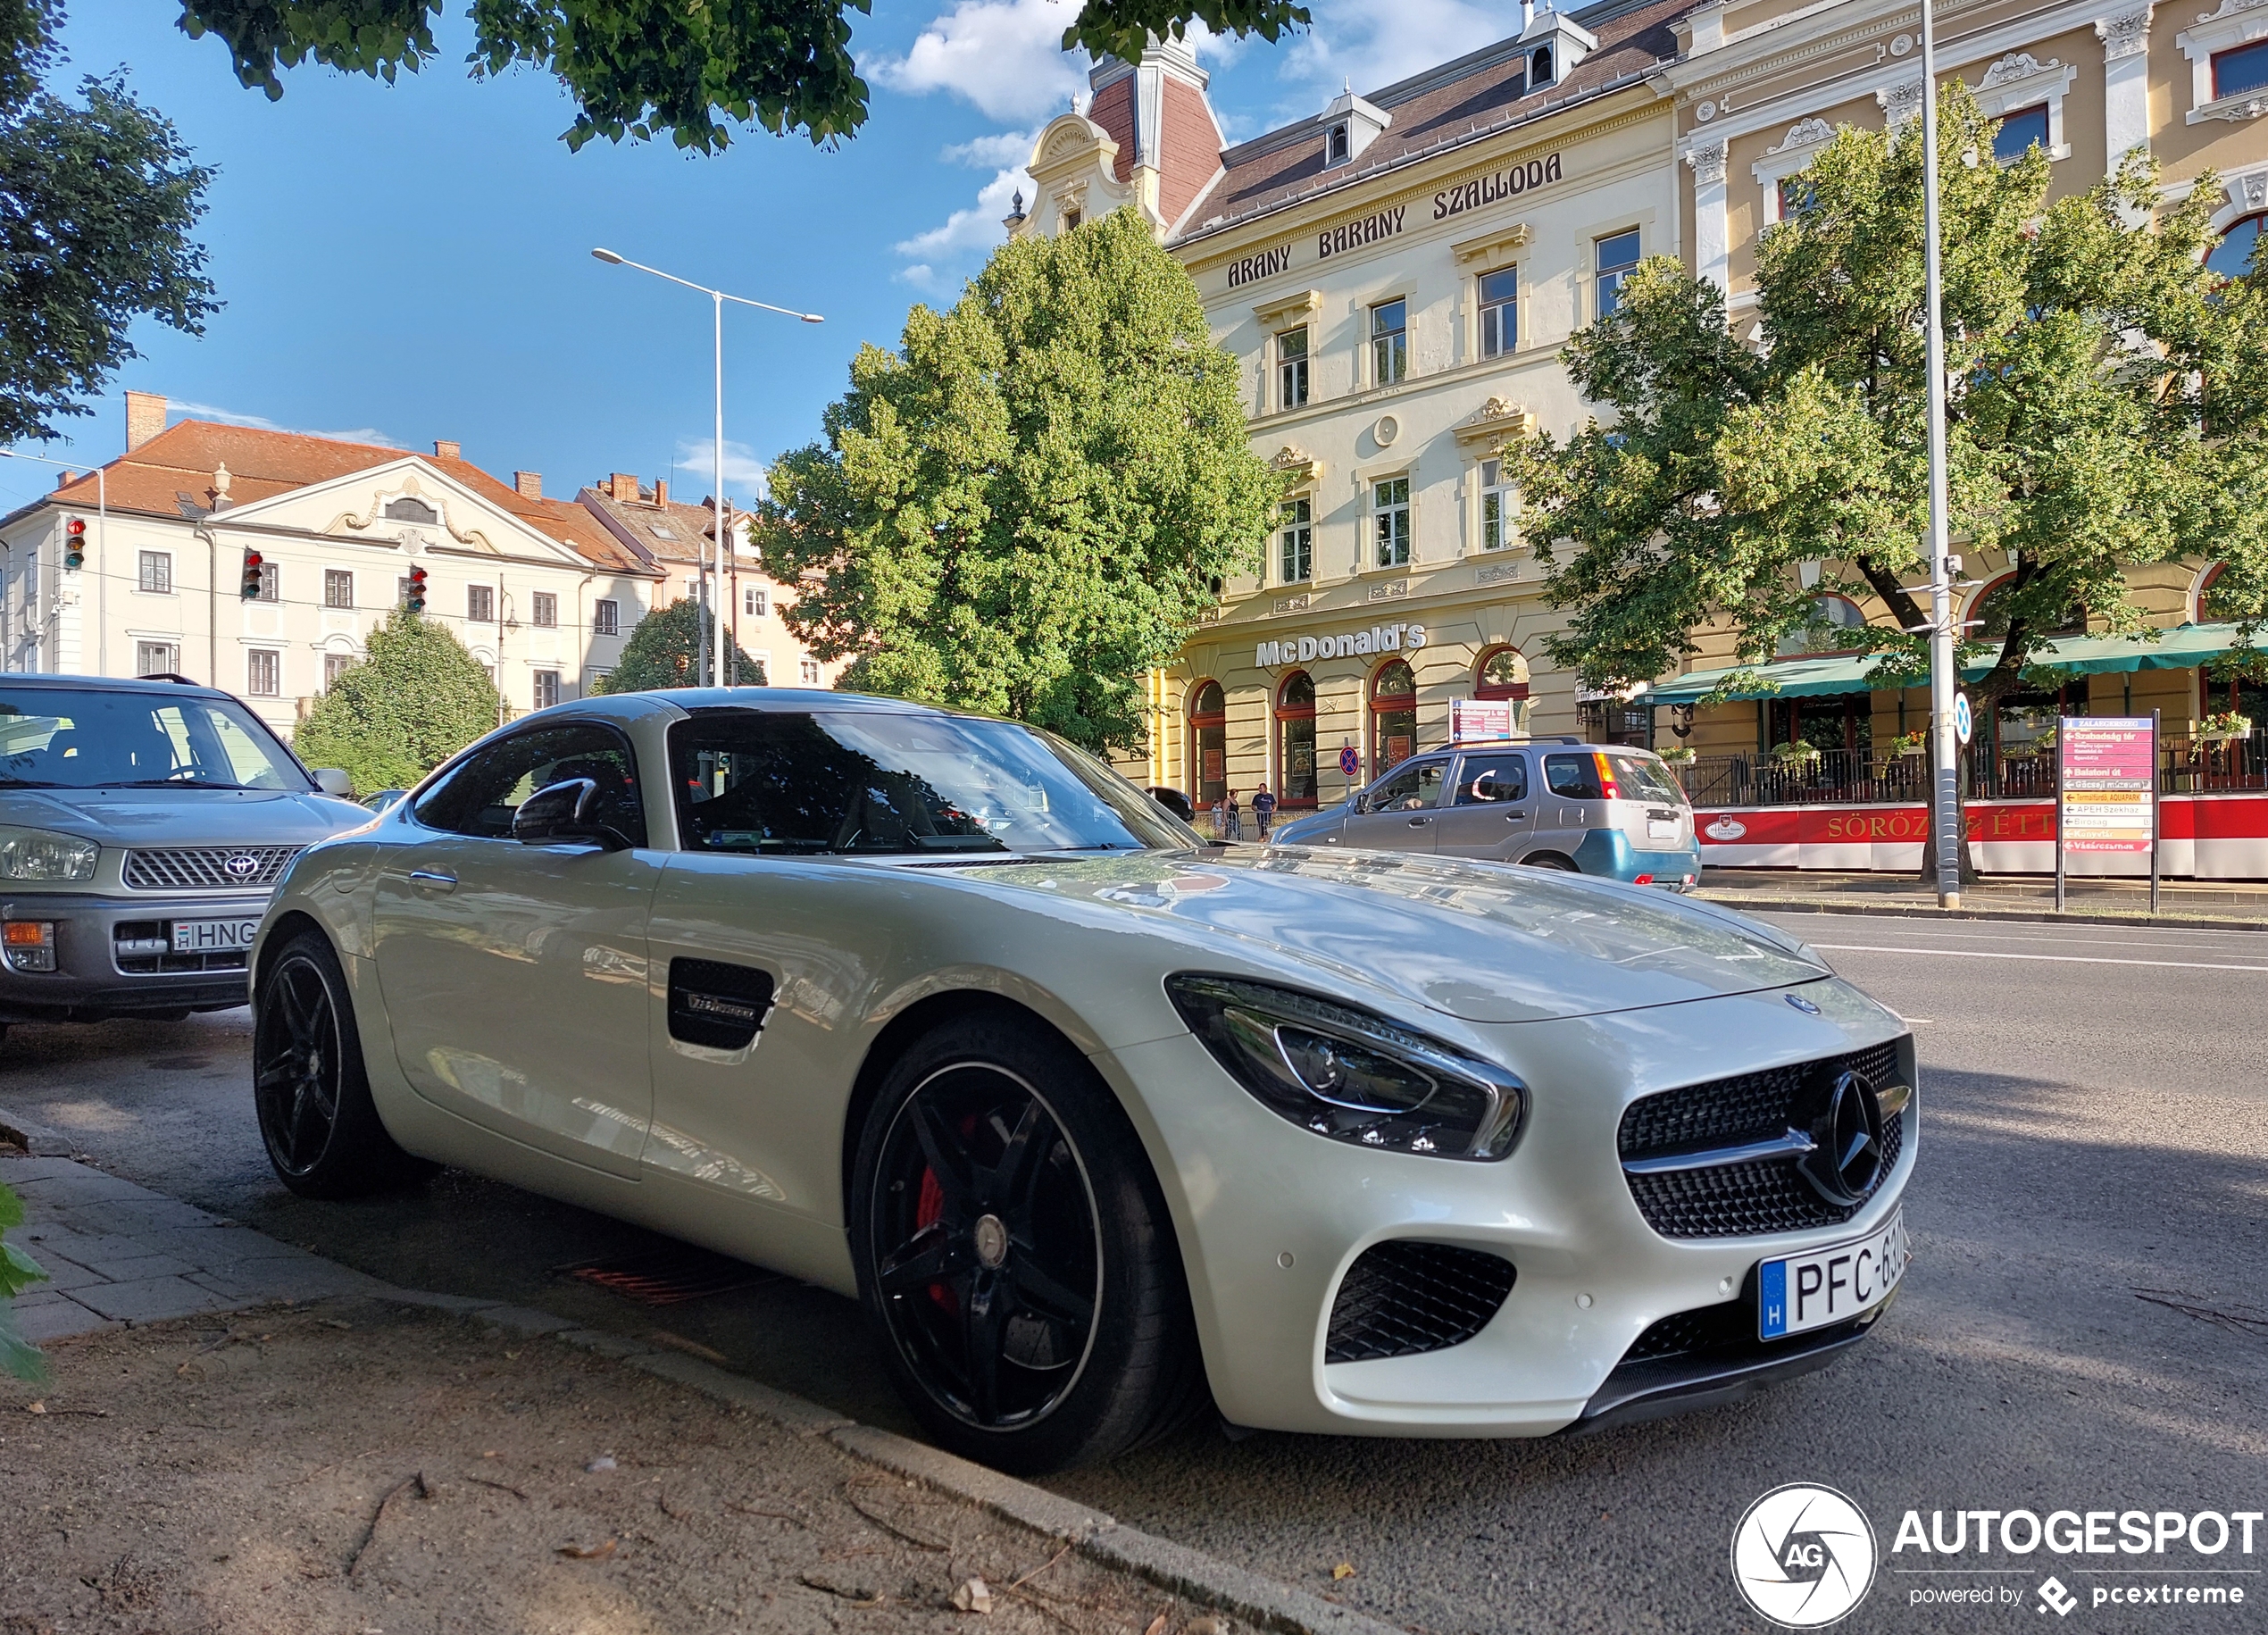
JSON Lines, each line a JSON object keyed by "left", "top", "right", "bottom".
{"left": 1506, "top": 84, "right": 2268, "bottom": 698}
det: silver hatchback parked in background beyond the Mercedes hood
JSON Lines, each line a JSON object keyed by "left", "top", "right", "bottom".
{"left": 1272, "top": 739, "right": 1701, "bottom": 891}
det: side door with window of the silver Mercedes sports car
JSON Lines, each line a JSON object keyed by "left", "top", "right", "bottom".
{"left": 372, "top": 722, "right": 667, "bottom": 1174}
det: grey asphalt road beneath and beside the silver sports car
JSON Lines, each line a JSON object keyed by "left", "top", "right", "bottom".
{"left": 0, "top": 913, "right": 2268, "bottom": 1631}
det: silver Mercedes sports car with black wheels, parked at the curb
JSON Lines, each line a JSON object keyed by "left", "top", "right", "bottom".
{"left": 254, "top": 689, "right": 1916, "bottom": 1470}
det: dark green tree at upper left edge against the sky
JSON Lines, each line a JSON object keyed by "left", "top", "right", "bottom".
{"left": 0, "top": 0, "right": 218, "bottom": 445}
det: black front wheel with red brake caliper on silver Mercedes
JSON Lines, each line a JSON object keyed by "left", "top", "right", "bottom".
{"left": 851, "top": 1014, "right": 1206, "bottom": 1474}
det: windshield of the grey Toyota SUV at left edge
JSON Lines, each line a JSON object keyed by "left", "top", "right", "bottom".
{"left": 0, "top": 687, "right": 311, "bottom": 794}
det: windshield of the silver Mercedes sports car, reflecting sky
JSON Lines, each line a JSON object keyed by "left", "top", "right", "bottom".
{"left": 669, "top": 710, "right": 1202, "bottom": 857}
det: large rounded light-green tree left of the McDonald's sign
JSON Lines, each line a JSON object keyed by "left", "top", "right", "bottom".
{"left": 753, "top": 211, "right": 1281, "bottom": 748}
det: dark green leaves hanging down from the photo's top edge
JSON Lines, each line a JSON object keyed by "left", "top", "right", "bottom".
{"left": 160, "top": 0, "right": 1306, "bottom": 152}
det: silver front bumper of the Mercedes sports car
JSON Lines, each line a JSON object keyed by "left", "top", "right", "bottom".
{"left": 1097, "top": 980, "right": 1919, "bottom": 1436}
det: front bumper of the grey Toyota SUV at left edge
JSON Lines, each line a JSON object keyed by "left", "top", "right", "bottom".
{"left": 0, "top": 891, "right": 270, "bottom": 1022}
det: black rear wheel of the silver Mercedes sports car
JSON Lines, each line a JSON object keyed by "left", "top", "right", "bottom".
{"left": 252, "top": 932, "right": 440, "bottom": 1197}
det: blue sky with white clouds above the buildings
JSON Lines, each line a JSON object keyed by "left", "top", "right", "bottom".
{"left": 0, "top": 0, "right": 1517, "bottom": 510}
